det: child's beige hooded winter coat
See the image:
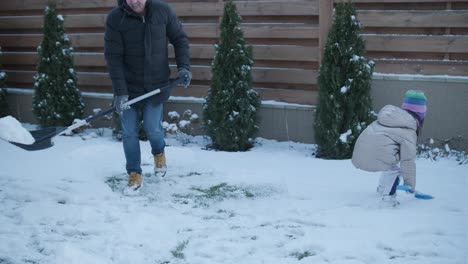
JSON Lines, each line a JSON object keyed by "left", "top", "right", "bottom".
{"left": 352, "top": 105, "right": 417, "bottom": 189}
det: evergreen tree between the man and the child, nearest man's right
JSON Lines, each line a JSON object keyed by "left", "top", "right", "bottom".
{"left": 203, "top": 0, "right": 260, "bottom": 151}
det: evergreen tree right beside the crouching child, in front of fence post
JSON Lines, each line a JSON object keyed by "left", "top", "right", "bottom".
{"left": 314, "top": 2, "right": 374, "bottom": 159}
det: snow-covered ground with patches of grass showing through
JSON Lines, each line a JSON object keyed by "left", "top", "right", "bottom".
{"left": 0, "top": 125, "right": 468, "bottom": 264}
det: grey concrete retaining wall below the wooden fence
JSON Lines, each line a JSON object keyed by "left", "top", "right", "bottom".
{"left": 4, "top": 74, "right": 468, "bottom": 150}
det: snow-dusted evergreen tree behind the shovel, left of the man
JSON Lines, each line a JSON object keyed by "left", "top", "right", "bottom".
{"left": 33, "top": 3, "right": 84, "bottom": 126}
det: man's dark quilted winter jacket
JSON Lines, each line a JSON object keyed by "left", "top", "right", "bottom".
{"left": 105, "top": 0, "right": 190, "bottom": 102}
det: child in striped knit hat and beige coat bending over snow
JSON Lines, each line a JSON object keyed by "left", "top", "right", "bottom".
{"left": 352, "top": 90, "right": 427, "bottom": 206}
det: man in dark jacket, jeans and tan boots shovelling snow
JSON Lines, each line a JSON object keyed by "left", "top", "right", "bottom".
{"left": 105, "top": 0, "right": 192, "bottom": 190}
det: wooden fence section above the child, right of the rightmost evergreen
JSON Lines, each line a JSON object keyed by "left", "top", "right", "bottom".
{"left": 337, "top": 0, "right": 468, "bottom": 76}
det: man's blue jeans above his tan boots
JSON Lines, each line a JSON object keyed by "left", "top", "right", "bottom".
{"left": 120, "top": 100, "right": 166, "bottom": 174}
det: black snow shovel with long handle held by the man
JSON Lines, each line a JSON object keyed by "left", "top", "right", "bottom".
{"left": 9, "top": 78, "right": 183, "bottom": 151}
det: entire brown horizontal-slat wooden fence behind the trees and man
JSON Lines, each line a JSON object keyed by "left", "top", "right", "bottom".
{"left": 0, "top": 0, "right": 468, "bottom": 104}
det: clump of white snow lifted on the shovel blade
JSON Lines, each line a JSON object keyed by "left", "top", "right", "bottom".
{"left": 0, "top": 116, "right": 34, "bottom": 145}
